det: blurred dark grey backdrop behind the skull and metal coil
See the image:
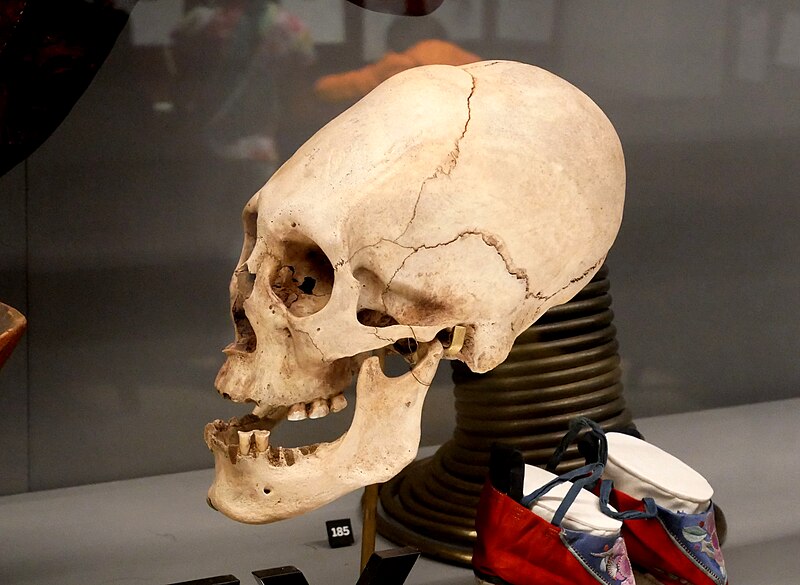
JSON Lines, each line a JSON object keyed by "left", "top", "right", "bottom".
{"left": 0, "top": 0, "right": 800, "bottom": 494}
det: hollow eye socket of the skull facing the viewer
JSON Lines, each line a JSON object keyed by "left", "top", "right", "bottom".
{"left": 270, "top": 235, "right": 334, "bottom": 317}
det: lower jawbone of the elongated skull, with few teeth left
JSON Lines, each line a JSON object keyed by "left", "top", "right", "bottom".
{"left": 206, "top": 342, "right": 442, "bottom": 524}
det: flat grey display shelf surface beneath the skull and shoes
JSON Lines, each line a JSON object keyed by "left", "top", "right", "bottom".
{"left": 0, "top": 398, "right": 800, "bottom": 585}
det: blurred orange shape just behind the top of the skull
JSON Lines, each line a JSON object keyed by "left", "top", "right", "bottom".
{"left": 314, "top": 39, "right": 481, "bottom": 102}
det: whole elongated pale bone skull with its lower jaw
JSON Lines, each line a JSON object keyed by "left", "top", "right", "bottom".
{"left": 206, "top": 61, "right": 625, "bottom": 523}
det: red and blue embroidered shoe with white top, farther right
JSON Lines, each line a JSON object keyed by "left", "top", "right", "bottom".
{"left": 600, "top": 432, "right": 728, "bottom": 585}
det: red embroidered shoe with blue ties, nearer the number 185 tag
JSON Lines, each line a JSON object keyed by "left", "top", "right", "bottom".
{"left": 472, "top": 440, "right": 635, "bottom": 585}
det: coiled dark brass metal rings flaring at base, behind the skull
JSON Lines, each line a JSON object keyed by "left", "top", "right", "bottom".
{"left": 378, "top": 267, "right": 632, "bottom": 565}
